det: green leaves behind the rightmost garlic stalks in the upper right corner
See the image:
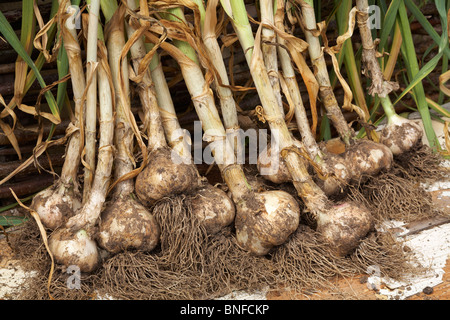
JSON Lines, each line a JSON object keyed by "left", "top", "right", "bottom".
{"left": 327, "top": 0, "right": 450, "bottom": 149}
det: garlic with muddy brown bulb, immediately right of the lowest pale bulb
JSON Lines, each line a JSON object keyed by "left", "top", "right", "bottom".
{"left": 93, "top": 0, "right": 160, "bottom": 253}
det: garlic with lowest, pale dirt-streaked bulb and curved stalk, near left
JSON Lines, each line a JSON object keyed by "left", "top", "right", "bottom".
{"left": 49, "top": 0, "right": 105, "bottom": 272}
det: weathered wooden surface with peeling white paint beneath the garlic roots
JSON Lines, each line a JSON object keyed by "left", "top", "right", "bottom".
{"left": 0, "top": 189, "right": 450, "bottom": 300}
